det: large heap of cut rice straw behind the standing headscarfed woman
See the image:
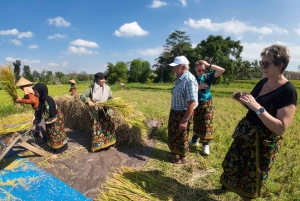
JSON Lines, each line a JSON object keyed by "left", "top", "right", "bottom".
{"left": 54, "top": 95, "right": 149, "bottom": 146}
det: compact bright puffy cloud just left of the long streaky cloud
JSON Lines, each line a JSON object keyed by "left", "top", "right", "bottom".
{"left": 114, "top": 22, "right": 149, "bottom": 37}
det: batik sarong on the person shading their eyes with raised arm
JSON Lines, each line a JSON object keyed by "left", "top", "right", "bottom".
{"left": 193, "top": 100, "right": 214, "bottom": 143}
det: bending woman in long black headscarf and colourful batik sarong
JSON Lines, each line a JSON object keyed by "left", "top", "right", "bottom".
{"left": 33, "top": 83, "right": 68, "bottom": 154}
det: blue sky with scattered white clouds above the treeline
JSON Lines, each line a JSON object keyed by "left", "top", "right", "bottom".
{"left": 0, "top": 0, "right": 300, "bottom": 74}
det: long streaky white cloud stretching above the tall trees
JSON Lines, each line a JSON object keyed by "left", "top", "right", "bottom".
{"left": 184, "top": 18, "right": 288, "bottom": 35}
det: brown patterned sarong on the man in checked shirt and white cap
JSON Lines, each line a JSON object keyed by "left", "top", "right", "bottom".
{"left": 168, "top": 110, "right": 190, "bottom": 156}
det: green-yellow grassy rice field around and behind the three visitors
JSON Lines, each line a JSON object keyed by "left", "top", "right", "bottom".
{"left": 0, "top": 80, "right": 300, "bottom": 201}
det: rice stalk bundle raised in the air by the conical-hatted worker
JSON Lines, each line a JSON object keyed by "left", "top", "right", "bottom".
{"left": 0, "top": 66, "right": 18, "bottom": 99}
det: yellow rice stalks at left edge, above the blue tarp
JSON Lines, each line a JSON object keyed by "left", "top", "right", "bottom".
{"left": 0, "top": 111, "right": 33, "bottom": 135}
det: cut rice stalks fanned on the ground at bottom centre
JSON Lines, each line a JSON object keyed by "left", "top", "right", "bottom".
{"left": 99, "top": 167, "right": 176, "bottom": 201}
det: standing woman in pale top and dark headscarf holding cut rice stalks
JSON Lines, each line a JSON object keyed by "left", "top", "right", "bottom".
{"left": 80, "top": 72, "right": 116, "bottom": 152}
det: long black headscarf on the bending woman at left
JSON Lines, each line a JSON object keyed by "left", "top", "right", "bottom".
{"left": 33, "top": 83, "right": 57, "bottom": 124}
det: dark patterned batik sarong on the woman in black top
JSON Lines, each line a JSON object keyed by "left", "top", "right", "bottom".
{"left": 220, "top": 118, "right": 282, "bottom": 200}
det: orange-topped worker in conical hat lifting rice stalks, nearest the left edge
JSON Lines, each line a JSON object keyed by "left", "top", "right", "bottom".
{"left": 14, "top": 77, "right": 39, "bottom": 109}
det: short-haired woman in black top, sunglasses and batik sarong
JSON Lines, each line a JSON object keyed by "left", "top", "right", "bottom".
{"left": 221, "top": 44, "right": 297, "bottom": 200}
